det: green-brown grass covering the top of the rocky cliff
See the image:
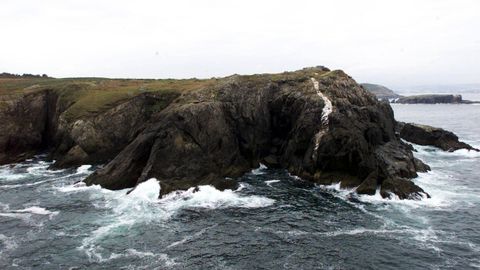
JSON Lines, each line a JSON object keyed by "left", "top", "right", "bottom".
{"left": 0, "top": 68, "right": 338, "bottom": 119}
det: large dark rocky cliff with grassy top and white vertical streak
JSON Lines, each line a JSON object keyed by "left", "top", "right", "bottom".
{"left": 0, "top": 67, "right": 428, "bottom": 198}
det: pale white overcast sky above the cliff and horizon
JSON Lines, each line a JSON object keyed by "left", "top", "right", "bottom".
{"left": 0, "top": 0, "right": 480, "bottom": 88}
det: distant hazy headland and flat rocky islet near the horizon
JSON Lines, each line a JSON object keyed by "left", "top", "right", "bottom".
{"left": 361, "top": 83, "right": 480, "bottom": 104}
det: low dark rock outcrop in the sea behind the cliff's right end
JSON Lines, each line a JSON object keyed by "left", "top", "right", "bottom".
{"left": 397, "top": 122, "right": 480, "bottom": 152}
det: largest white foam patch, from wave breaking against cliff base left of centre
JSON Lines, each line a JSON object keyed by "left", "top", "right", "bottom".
{"left": 78, "top": 178, "right": 274, "bottom": 261}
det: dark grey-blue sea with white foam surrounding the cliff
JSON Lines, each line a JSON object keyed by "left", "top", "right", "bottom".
{"left": 0, "top": 102, "right": 480, "bottom": 269}
